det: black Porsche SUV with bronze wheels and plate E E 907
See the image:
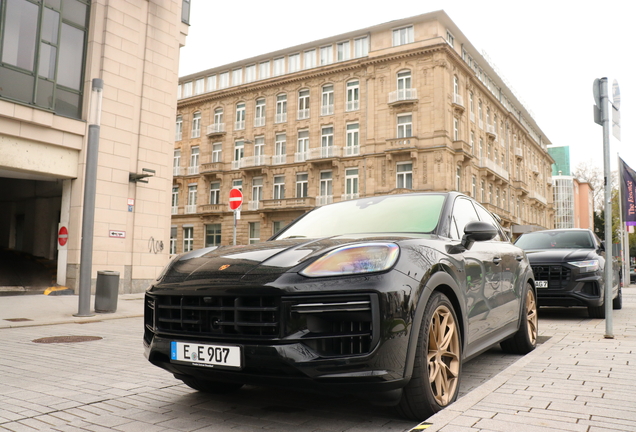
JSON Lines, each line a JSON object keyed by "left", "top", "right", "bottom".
{"left": 144, "top": 192, "right": 537, "bottom": 420}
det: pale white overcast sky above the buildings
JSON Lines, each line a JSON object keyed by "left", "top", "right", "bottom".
{"left": 179, "top": 0, "right": 636, "bottom": 176}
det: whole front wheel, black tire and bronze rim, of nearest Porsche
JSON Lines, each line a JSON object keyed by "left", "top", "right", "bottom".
{"left": 395, "top": 292, "right": 462, "bottom": 421}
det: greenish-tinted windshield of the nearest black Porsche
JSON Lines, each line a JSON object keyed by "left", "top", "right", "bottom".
{"left": 276, "top": 194, "right": 446, "bottom": 240}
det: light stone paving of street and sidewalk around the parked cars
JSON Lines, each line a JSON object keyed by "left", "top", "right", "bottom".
{"left": 0, "top": 289, "right": 636, "bottom": 432}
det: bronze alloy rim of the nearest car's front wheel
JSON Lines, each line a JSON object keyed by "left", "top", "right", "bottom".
{"left": 427, "top": 305, "right": 460, "bottom": 406}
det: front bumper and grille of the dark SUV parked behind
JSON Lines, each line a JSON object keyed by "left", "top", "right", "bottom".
{"left": 531, "top": 263, "right": 604, "bottom": 307}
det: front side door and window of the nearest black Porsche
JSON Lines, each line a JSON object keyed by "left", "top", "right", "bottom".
{"left": 451, "top": 197, "right": 499, "bottom": 346}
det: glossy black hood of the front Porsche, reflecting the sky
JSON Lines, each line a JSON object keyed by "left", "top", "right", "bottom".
{"left": 158, "top": 236, "right": 424, "bottom": 284}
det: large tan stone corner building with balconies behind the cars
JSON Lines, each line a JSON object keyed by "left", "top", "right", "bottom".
{"left": 170, "top": 11, "right": 553, "bottom": 253}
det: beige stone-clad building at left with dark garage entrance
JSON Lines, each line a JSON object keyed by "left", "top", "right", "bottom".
{"left": 0, "top": 0, "right": 189, "bottom": 292}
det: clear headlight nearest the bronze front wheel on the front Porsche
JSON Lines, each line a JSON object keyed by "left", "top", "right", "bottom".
{"left": 300, "top": 243, "right": 400, "bottom": 277}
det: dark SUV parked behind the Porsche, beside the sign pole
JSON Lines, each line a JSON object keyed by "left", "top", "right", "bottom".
{"left": 515, "top": 228, "right": 623, "bottom": 318}
